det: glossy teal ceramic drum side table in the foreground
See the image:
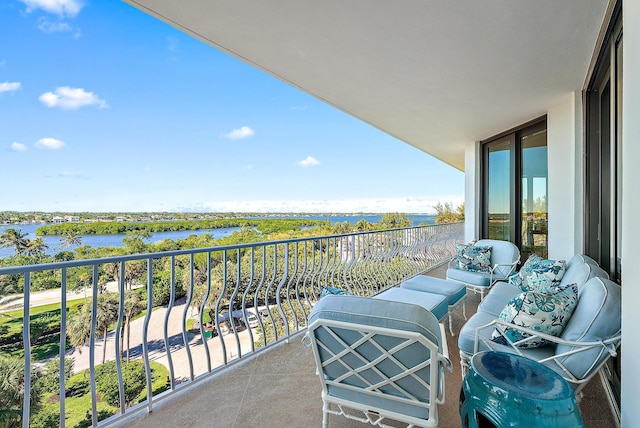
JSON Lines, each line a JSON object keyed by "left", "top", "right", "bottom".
{"left": 460, "top": 351, "right": 584, "bottom": 428}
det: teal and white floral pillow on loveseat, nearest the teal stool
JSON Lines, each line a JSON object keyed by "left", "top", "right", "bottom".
{"left": 491, "top": 284, "right": 578, "bottom": 348}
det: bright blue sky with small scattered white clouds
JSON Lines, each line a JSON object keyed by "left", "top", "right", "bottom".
{"left": 0, "top": 0, "right": 464, "bottom": 213}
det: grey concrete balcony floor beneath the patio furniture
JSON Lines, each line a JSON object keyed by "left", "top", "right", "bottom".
{"left": 126, "top": 268, "right": 616, "bottom": 428}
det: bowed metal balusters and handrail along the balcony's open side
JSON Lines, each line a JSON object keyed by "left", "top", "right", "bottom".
{"left": 0, "top": 223, "right": 463, "bottom": 427}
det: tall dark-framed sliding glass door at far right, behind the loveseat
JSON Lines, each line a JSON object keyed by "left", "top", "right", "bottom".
{"left": 584, "top": 2, "right": 628, "bottom": 419}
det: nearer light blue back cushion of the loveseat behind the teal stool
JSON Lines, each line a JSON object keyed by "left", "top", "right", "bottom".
{"left": 556, "top": 277, "right": 622, "bottom": 379}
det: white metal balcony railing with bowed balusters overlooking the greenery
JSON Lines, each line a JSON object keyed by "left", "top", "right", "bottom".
{"left": 0, "top": 223, "right": 463, "bottom": 427}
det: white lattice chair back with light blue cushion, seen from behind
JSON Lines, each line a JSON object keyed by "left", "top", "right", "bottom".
{"left": 307, "top": 296, "right": 451, "bottom": 423}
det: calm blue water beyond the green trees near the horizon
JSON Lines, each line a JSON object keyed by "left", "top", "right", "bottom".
{"left": 0, "top": 214, "right": 435, "bottom": 258}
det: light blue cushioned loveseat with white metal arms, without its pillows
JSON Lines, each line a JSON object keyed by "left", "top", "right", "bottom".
{"left": 458, "top": 255, "right": 621, "bottom": 394}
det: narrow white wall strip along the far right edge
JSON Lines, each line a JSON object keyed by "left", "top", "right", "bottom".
{"left": 621, "top": 0, "right": 640, "bottom": 428}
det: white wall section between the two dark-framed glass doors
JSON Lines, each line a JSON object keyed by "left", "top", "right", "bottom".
{"left": 547, "top": 92, "right": 583, "bottom": 260}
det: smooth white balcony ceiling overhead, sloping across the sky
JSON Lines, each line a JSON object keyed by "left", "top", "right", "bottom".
{"left": 125, "top": 0, "right": 608, "bottom": 170}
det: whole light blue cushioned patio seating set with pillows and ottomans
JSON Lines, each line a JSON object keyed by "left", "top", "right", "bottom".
{"left": 303, "top": 240, "right": 621, "bottom": 427}
